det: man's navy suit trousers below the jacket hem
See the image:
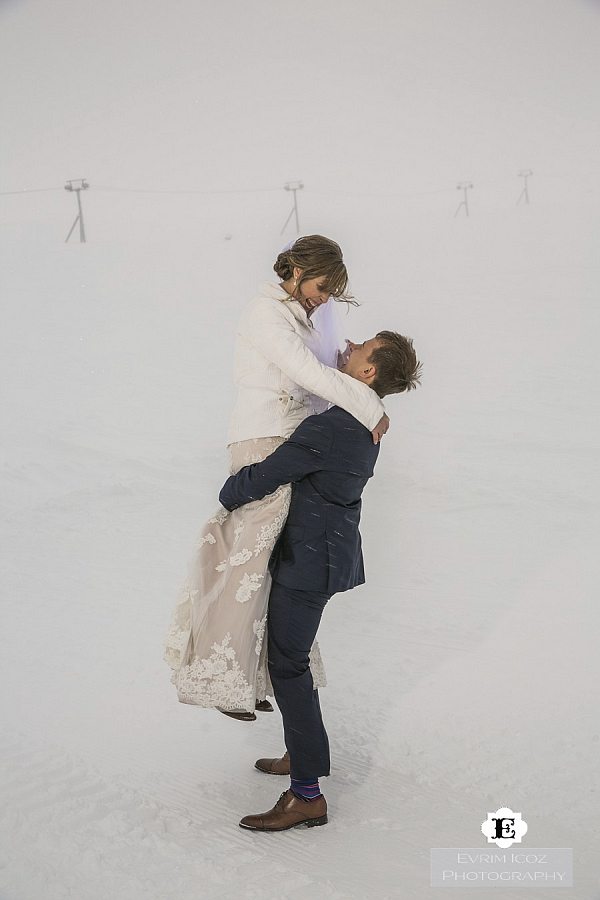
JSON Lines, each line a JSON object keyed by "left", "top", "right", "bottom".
{"left": 267, "top": 582, "right": 331, "bottom": 781}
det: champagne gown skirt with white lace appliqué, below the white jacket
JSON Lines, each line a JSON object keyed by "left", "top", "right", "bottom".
{"left": 164, "top": 437, "right": 326, "bottom": 712}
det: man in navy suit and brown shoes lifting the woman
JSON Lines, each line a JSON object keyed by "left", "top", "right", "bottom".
{"left": 219, "top": 331, "right": 421, "bottom": 831}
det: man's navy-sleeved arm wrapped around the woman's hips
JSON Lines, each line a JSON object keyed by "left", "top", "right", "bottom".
{"left": 219, "top": 415, "right": 333, "bottom": 510}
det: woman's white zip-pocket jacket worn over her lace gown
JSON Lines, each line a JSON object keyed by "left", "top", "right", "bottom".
{"left": 227, "top": 282, "right": 385, "bottom": 444}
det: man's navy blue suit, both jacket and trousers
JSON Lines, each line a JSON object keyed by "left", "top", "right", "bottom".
{"left": 219, "top": 406, "right": 379, "bottom": 780}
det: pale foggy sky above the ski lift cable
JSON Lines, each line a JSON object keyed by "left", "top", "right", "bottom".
{"left": 0, "top": 0, "right": 600, "bottom": 202}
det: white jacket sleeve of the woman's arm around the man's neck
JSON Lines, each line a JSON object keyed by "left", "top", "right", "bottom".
{"left": 243, "top": 301, "right": 385, "bottom": 431}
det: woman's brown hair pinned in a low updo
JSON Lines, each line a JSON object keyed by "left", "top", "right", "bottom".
{"left": 273, "top": 234, "right": 356, "bottom": 304}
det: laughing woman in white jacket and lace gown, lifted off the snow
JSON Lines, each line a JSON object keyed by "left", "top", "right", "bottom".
{"left": 164, "top": 235, "right": 389, "bottom": 720}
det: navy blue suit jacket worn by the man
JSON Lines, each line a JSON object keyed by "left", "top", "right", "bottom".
{"left": 219, "top": 406, "right": 379, "bottom": 595}
